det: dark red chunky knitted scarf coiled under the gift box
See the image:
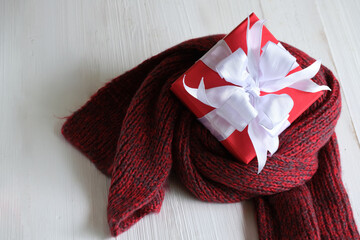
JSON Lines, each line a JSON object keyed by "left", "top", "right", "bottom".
{"left": 62, "top": 35, "right": 359, "bottom": 239}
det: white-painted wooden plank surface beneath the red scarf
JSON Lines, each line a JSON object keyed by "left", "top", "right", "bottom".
{"left": 0, "top": 0, "right": 360, "bottom": 240}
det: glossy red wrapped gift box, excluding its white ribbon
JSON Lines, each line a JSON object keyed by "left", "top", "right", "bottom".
{"left": 171, "top": 13, "right": 323, "bottom": 163}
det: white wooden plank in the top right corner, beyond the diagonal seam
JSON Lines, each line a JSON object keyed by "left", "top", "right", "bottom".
{"left": 317, "top": 0, "right": 360, "bottom": 143}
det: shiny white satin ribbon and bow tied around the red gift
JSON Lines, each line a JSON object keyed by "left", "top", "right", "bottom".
{"left": 183, "top": 18, "right": 330, "bottom": 173}
